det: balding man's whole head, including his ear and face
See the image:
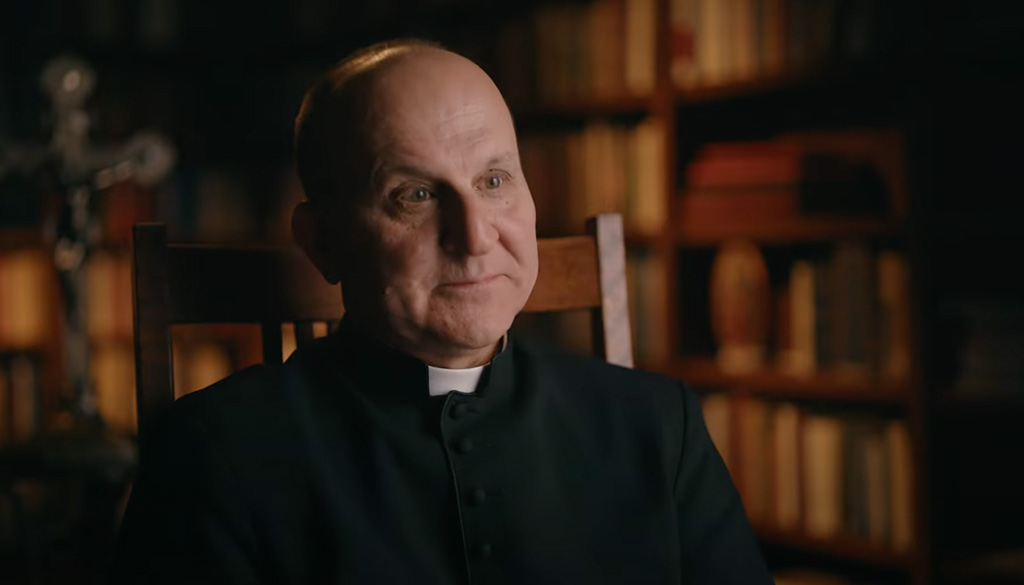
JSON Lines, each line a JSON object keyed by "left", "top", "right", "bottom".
{"left": 292, "top": 44, "right": 538, "bottom": 368}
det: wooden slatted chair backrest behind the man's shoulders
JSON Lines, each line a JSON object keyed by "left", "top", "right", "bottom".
{"left": 132, "top": 214, "right": 633, "bottom": 436}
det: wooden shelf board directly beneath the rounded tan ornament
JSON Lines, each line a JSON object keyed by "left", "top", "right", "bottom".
{"left": 663, "top": 358, "right": 911, "bottom": 407}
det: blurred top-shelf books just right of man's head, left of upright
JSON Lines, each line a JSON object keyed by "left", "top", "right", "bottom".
{"left": 497, "top": 0, "right": 657, "bottom": 106}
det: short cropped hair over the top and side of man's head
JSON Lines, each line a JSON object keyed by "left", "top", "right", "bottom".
{"left": 295, "top": 39, "right": 511, "bottom": 207}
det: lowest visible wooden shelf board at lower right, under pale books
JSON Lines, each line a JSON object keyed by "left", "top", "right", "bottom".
{"left": 754, "top": 526, "right": 912, "bottom": 571}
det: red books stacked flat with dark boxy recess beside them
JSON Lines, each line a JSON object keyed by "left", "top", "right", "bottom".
{"left": 677, "top": 129, "right": 907, "bottom": 233}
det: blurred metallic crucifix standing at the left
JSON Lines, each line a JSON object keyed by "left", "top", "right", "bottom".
{"left": 0, "top": 56, "right": 175, "bottom": 428}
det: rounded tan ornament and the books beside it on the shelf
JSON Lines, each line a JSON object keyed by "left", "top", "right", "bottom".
{"left": 710, "top": 240, "right": 911, "bottom": 380}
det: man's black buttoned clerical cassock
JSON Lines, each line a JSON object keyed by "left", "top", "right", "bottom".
{"left": 112, "top": 321, "right": 771, "bottom": 585}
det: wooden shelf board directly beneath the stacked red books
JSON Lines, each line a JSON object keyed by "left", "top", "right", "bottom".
{"left": 675, "top": 217, "right": 905, "bottom": 246}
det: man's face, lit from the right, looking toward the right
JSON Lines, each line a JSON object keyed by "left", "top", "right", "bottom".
{"left": 325, "top": 50, "right": 537, "bottom": 368}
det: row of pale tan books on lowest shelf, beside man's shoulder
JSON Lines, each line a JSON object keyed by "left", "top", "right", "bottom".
{"left": 701, "top": 393, "right": 914, "bottom": 551}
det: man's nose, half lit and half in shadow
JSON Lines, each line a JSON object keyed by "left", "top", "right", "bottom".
{"left": 441, "top": 190, "right": 498, "bottom": 256}
